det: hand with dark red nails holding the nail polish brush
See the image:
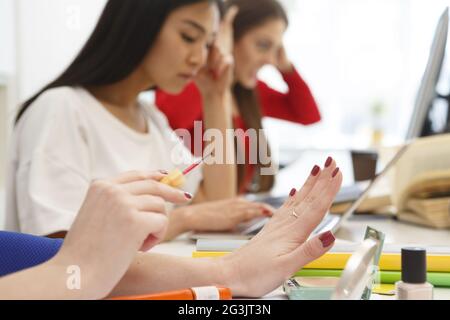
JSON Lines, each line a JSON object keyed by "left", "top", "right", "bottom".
{"left": 55, "top": 172, "right": 188, "bottom": 298}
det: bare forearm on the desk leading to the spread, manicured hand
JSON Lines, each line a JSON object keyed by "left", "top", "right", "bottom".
{"left": 110, "top": 253, "right": 232, "bottom": 297}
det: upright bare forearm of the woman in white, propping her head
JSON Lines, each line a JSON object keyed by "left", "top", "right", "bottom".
{"left": 201, "top": 92, "right": 237, "bottom": 201}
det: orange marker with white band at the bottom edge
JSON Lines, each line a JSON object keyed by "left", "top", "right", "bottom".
{"left": 111, "top": 287, "right": 232, "bottom": 300}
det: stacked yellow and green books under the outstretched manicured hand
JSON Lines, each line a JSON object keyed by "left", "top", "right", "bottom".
{"left": 192, "top": 239, "right": 450, "bottom": 288}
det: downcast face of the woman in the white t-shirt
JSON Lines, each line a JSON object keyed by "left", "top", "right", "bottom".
{"left": 143, "top": 1, "right": 220, "bottom": 94}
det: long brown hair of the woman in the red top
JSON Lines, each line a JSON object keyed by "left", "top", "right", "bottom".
{"left": 226, "top": 0, "right": 289, "bottom": 192}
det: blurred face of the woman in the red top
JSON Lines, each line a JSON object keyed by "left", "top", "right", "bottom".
{"left": 234, "top": 19, "right": 286, "bottom": 89}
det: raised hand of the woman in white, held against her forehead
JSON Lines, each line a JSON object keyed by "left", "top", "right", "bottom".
{"left": 196, "top": 7, "right": 238, "bottom": 98}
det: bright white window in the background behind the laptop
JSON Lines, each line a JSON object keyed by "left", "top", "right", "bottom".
{"left": 261, "top": 0, "right": 450, "bottom": 154}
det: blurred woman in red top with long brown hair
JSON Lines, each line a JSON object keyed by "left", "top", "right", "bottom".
{"left": 156, "top": 0, "right": 321, "bottom": 193}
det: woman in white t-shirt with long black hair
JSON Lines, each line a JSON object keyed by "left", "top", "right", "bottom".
{"left": 6, "top": 0, "right": 272, "bottom": 239}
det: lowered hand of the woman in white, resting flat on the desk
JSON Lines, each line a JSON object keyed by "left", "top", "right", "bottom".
{"left": 180, "top": 198, "right": 274, "bottom": 231}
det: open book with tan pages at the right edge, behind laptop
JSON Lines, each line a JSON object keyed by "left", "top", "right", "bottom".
{"left": 392, "top": 134, "right": 450, "bottom": 228}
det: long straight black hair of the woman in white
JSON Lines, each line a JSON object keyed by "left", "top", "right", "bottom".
{"left": 16, "top": 0, "right": 224, "bottom": 123}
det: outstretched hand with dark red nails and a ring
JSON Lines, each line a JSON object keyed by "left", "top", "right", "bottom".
{"left": 218, "top": 158, "right": 342, "bottom": 297}
